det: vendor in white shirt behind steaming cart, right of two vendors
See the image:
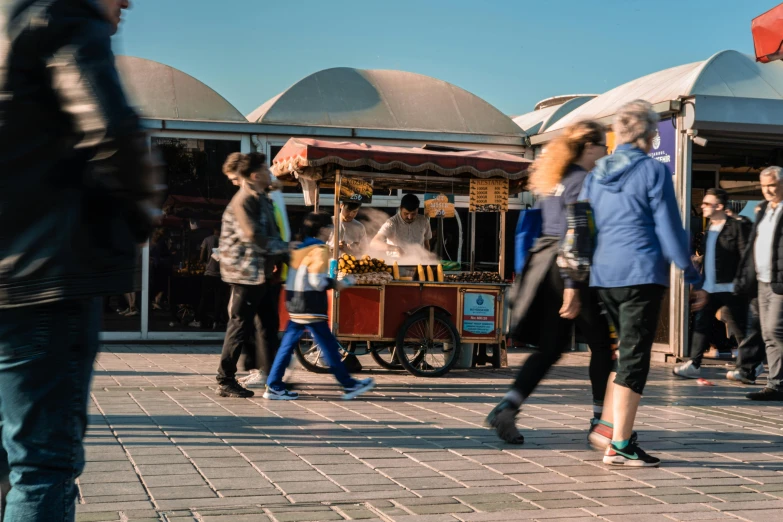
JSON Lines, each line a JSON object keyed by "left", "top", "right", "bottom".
{"left": 372, "top": 194, "right": 432, "bottom": 254}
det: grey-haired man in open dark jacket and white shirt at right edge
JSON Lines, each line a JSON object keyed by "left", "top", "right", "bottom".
{"left": 735, "top": 167, "right": 783, "bottom": 401}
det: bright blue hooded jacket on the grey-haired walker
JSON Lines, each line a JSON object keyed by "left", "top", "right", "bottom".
{"left": 579, "top": 145, "right": 701, "bottom": 288}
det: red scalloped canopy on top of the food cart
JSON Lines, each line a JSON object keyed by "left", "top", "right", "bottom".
{"left": 272, "top": 138, "right": 532, "bottom": 180}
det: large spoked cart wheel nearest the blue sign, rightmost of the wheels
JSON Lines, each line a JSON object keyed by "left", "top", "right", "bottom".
{"left": 396, "top": 310, "right": 461, "bottom": 377}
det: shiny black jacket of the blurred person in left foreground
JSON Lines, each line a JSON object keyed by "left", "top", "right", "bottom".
{"left": 0, "top": 0, "right": 159, "bottom": 308}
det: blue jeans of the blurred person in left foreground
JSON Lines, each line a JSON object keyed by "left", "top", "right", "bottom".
{"left": 0, "top": 299, "right": 101, "bottom": 522}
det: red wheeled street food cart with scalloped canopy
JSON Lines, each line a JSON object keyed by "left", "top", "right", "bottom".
{"left": 272, "top": 138, "right": 531, "bottom": 377}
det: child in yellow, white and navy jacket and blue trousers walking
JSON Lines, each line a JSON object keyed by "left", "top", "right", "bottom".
{"left": 264, "top": 213, "right": 375, "bottom": 400}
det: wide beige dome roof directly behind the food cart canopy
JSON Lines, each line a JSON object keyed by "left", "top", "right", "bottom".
{"left": 247, "top": 67, "right": 521, "bottom": 136}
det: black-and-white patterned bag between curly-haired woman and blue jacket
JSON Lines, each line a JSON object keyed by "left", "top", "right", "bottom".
{"left": 557, "top": 201, "right": 595, "bottom": 282}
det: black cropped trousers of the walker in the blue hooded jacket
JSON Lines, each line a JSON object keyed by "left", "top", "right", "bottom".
{"left": 598, "top": 285, "right": 666, "bottom": 395}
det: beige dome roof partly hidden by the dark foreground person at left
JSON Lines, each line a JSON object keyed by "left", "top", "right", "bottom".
{"left": 117, "top": 56, "right": 247, "bottom": 123}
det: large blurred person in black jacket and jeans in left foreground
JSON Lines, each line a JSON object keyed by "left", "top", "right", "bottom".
{"left": 0, "top": 0, "right": 160, "bottom": 522}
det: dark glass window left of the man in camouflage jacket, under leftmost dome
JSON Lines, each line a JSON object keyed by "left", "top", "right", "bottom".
{"left": 149, "top": 138, "right": 241, "bottom": 332}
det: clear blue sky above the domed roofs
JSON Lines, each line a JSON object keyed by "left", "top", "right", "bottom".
{"left": 115, "top": 0, "right": 778, "bottom": 115}
